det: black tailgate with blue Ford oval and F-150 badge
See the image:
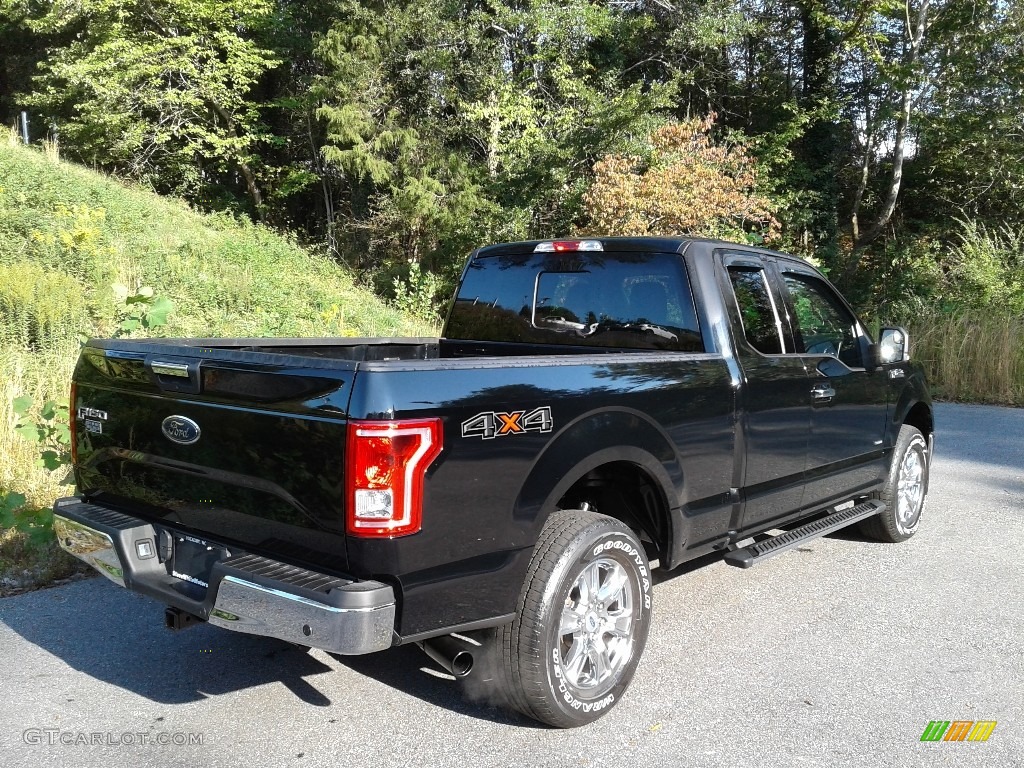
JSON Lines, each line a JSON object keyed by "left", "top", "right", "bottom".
{"left": 72, "top": 341, "right": 355, "bottom": 572}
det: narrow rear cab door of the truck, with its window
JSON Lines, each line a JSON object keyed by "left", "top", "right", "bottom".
{"left": 723, "top": 252, "right": 811, "bottom": 528}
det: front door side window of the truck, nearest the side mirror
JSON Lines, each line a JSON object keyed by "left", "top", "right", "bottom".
{"left": 782, "top": 272, "right": 864, "bottom": 368}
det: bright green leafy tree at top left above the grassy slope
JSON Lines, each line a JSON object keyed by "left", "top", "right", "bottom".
{"left": 28, "top": 0, "right": 280, "bottom": 213}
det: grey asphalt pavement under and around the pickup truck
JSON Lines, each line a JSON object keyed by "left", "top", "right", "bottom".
{"left": 0, "top": 403, "right": 1024, "bottom": 768}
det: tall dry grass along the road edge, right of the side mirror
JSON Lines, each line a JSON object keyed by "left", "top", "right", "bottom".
{"left": 907, "top": 308, "right": 1024, "bottom": 406}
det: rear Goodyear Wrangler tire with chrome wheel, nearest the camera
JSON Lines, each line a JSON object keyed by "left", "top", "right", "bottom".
{"left": 496, "top": 510, "right": 651, "bottom": 728}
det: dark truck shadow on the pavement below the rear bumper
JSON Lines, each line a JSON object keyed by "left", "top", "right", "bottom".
{"left": 0, "top": 578, "right": 536, "bottom": 725}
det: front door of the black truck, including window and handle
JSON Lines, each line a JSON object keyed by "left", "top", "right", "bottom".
{"left": 776, "top": 259, "right": 888, "bottom": 507}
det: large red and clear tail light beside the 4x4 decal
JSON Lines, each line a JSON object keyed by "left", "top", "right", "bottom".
{"left": 345, "top": 419, "right": 441, "bottom": 538}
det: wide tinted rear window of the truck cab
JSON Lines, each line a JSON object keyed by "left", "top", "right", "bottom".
{"left": 445, "top": 252, "right": 703, "bottom": 352}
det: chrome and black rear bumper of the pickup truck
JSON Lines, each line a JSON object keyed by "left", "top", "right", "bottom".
{"left": 53, "top": 498, "right": 395, "bottom": 654}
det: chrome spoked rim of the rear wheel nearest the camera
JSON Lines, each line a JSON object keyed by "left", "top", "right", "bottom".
{"left": 558, "top": 557, "right": 636, "bottom": 695}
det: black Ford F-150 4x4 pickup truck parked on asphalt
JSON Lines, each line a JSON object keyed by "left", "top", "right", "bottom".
{"left": 54, "top": 239, "right": 933, "bottom": 727}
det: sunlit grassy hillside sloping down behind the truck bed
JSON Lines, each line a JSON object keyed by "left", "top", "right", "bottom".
{"left": 0, "top": 141, "right": 431, "bottom": 506}
